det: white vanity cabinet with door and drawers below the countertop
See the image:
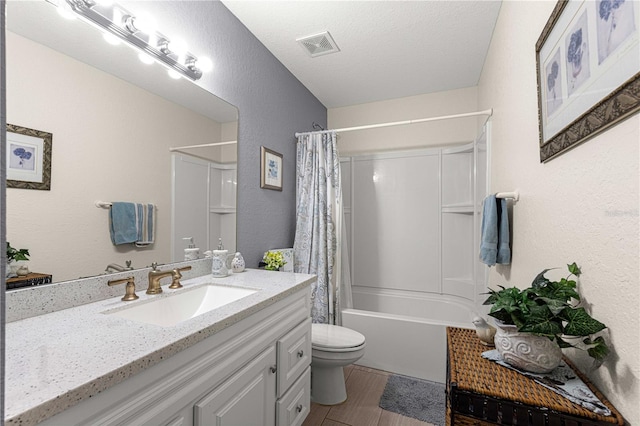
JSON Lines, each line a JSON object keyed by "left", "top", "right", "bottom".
{"left": 38, "top": 287, "right": 311, "bottom": 426}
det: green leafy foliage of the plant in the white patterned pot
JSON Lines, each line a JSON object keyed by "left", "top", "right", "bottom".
{"left": 484, "top": 262, "right": 609, "bottom": 372}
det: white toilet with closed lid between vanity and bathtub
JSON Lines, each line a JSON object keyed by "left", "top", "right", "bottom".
{"left": 311, "top": 324, "right": 365, "bottom": 405}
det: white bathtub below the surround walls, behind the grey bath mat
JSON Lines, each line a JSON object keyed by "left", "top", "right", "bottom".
{"left": 342, "top": 287, "right": 474, "bottom": 383}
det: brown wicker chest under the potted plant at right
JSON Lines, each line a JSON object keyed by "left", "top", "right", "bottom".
{"left": 446, "top": 327, "right": 624, "bottom": 426}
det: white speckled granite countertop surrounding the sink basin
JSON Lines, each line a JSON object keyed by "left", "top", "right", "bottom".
{"left": 4, "top": 270, "right": 315, "bottom": 425}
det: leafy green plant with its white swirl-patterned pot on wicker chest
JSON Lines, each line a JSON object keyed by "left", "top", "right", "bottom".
{"left": 484, "top": 263, "right": 609, "bottom": 373}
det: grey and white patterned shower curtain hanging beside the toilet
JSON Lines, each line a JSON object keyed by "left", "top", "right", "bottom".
{"left": 293, "top": 131, "right": 351, "bottom": 325}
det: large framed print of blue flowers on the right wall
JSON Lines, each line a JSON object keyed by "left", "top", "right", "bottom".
{"left": 536, "top": 0, "right": 640, "bottom": 162}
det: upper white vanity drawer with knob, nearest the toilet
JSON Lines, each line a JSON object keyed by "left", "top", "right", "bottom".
{"left": 277, "top": 318, "right": 311, "bottom": 398}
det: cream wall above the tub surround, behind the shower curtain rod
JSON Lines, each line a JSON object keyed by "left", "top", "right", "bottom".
{"left": 327, "top": 87, "right": 477, "bottom": 155}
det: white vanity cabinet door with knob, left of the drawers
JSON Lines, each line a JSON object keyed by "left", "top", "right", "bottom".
{"left": 194, "top": 346, "right": 276, "bottom": 426}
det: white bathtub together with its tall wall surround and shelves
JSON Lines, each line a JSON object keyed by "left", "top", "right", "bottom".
{"left": 341, "top": 134, "right": 490, "bottom": 383}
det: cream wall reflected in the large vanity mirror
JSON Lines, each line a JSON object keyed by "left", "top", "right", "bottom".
{"left": 6, "top": 32, "right": 225, "bottom": 281}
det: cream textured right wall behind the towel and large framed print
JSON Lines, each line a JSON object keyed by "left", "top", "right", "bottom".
{"left": 478, "top": 1, "right": 640, "bottom": 425}
